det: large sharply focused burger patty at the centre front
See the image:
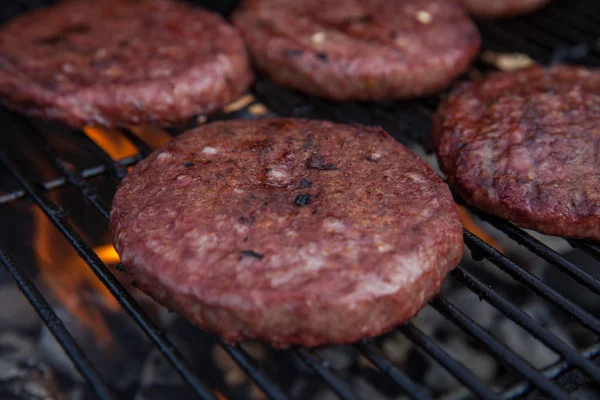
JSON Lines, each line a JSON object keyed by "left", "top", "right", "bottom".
{"left": 111, "top": 119, "right": 462, "bottom": 347}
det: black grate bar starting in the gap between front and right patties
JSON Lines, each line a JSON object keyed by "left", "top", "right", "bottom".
{"left": 469, "top": 207, "right": 600, "bottom": 295}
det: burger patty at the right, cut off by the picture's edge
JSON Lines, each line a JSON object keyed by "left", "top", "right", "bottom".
{"left": 433, "top": 66, "right": 600, "bottom": 240}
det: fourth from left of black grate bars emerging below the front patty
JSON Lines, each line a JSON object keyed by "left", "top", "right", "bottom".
{"left": 398, "top": 322, "right": 501, "bottom": 400}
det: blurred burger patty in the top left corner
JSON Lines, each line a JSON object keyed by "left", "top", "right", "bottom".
{"left": 0, "top": 0, "right": 252, "bottom": 127}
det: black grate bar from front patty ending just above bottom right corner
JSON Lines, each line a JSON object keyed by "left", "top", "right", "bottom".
{"left": 453, "top": 267, "right": 600, "bottom": 383}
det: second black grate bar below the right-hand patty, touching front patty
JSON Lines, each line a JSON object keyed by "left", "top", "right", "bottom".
{"left": 463, "top": 229, "right": 600, "bottom": 334}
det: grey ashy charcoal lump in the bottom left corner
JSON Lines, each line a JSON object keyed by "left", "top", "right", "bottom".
{"left": 0, "top": 333, "right": 65, "bottom": 400}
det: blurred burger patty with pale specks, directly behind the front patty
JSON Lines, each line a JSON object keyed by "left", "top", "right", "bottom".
{"left": 233, "top": 0, "right": 480, "bottom": 100}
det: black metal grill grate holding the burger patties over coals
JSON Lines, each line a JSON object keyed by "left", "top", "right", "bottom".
{"left": 0, "top": 1, "right": 600, "bottom": 400}
